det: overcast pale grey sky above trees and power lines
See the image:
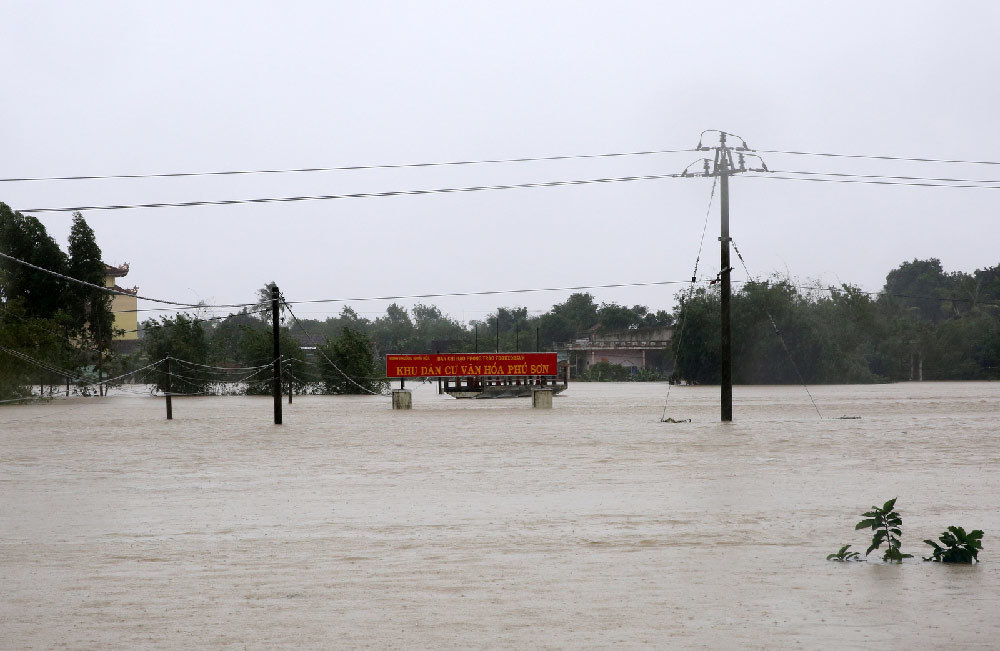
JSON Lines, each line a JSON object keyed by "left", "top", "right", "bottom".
{"left": 0, "top": 0, "right": 1000, "bottom": 320}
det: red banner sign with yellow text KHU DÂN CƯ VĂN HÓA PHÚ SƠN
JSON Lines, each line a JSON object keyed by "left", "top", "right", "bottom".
{"left": 385, "top": 353, "right": 559, "bottom": 377}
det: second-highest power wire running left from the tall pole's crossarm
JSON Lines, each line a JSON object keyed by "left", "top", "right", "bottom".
{"left": 13, "top": 174, "right": 683, "bottom": 213}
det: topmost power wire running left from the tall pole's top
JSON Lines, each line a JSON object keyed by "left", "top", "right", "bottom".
{"left": 0, "top": 149, "right": 695, "bottom": 183}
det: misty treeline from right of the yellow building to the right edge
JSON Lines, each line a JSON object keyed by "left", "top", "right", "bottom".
{"left": 144, "top": 258, "right": 1000, "bottom": 389}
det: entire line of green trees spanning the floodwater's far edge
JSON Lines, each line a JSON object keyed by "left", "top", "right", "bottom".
{"left": 0, "top": 203, "right": 1000, "bottom": 399}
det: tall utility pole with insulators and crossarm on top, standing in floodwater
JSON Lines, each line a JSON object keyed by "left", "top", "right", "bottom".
{"left": 683, "top": 129, "right": 768, "bottom": 422}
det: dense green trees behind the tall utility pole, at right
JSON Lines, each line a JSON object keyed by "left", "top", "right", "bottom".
{"left": 673, "top": 258, "right": 1000, "bottom": 384}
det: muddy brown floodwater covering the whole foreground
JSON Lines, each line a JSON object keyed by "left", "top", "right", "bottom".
{"left": 0, "top": 383, "right": 1000, "bottom": 649}
